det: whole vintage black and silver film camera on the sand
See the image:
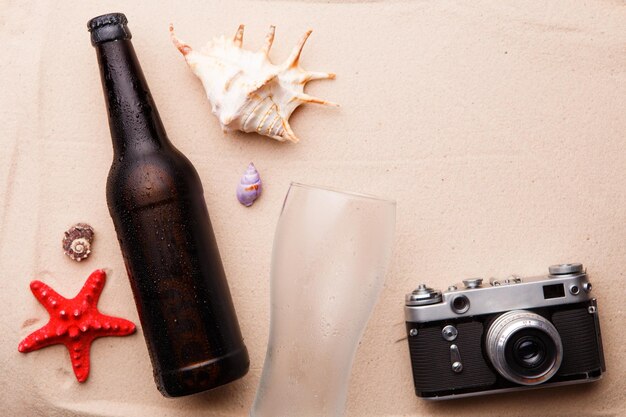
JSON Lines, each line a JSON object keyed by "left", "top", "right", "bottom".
{"left": 405, "top": 264, "right": 605, "bottom": 400}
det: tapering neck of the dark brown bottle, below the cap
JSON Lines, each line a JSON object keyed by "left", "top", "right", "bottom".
{"left": 95, "top": 39, "right": 171, "bottom": 156}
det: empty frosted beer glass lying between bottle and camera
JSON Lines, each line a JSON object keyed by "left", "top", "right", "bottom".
{"left": 250, "top": 183, "right": 396, "bottom": 417}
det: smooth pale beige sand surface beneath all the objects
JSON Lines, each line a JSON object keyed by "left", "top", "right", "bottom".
{"left": 0, "top": 0, "right": 626, "bottom": 417}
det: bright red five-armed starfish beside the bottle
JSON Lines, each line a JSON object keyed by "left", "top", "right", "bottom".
{"left": 17, "top": 269, "right": 135, "bottom": 382}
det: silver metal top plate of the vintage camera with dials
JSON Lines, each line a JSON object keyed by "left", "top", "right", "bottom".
{"left": 405, "top": 263, "right": 592, "bottom": 323}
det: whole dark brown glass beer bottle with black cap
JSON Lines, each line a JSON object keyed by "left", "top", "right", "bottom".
{"left": 87, "top": 13, "right": 249, "bottom": 397}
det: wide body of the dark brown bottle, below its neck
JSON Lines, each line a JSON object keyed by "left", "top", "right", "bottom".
{"left": 107, "top": 148, "right": 249, "bottom": 396}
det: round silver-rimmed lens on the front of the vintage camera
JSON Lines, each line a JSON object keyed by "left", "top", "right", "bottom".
{"left": 486, "top": 310, "right": 563, "bottom": 385}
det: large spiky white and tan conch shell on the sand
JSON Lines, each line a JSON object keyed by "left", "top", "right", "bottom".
{"left": 170, "top": 25, "right": 337, "bottom": 142}
